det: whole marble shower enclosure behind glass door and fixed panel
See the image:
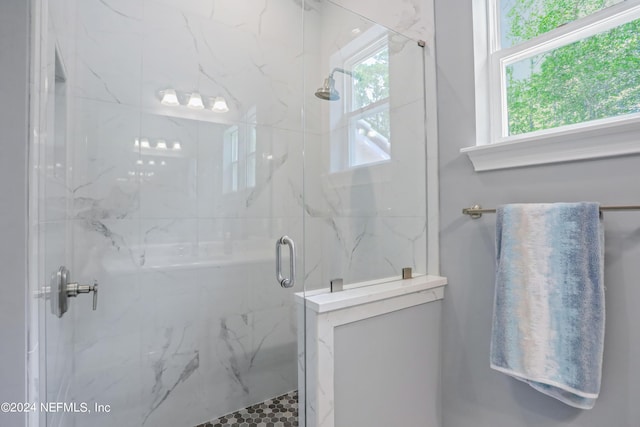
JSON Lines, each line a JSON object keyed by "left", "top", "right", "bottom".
{"left": 29, "top": 0, "right": 427, "bottom": 427}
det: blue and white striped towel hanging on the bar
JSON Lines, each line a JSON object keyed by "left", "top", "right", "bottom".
{"left": 491, "top": 202, "right": 605, "bottom": 409}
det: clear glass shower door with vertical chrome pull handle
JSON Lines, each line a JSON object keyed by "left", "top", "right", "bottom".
{"left": 32, "top": 0, "right": 305, "bottom": 427}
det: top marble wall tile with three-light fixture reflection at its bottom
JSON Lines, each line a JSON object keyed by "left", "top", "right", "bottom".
{"left": 142, "top": 1, "right": 303, "bottom": 130}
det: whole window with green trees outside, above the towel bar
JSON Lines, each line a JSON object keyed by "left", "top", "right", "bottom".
{"left": 463, "top": 0, "right": 640, "bottom": 170}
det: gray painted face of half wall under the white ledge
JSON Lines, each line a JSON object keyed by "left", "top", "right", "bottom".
{"left": 334, "top": 301, "right": 442, "bottom": 427}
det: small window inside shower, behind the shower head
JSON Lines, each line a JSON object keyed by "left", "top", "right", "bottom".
{"left": 331, "top": 27, "right": 391, "bottom": 172}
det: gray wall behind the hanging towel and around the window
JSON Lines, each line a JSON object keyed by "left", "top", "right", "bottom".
{"left": 436, "top": 0, "right": 640, "bottom": 427}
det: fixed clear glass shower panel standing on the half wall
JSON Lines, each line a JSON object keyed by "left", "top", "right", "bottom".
{"left": 304, "top": 2, "right": 427, "bottom": 289}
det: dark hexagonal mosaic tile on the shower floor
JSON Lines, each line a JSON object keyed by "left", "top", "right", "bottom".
{"left": 197, "top": 390, "right": 298, "bottom": 427}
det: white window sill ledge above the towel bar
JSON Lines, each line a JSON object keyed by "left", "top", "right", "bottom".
{"left": 460, "top": 117, "right": 640, "bottom": 172}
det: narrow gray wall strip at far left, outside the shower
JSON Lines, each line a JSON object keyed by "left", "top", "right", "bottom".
{"left": 0, "top": 0, "right": 29, "bottom": 427}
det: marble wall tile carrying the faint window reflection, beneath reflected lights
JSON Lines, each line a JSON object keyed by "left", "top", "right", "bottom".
{"left": 198, "top": 124, "right": 304, "bottom": 218}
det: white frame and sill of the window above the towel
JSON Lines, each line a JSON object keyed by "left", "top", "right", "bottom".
{"left": 461, "top": 0, "right": 640, "bottom": 171}
